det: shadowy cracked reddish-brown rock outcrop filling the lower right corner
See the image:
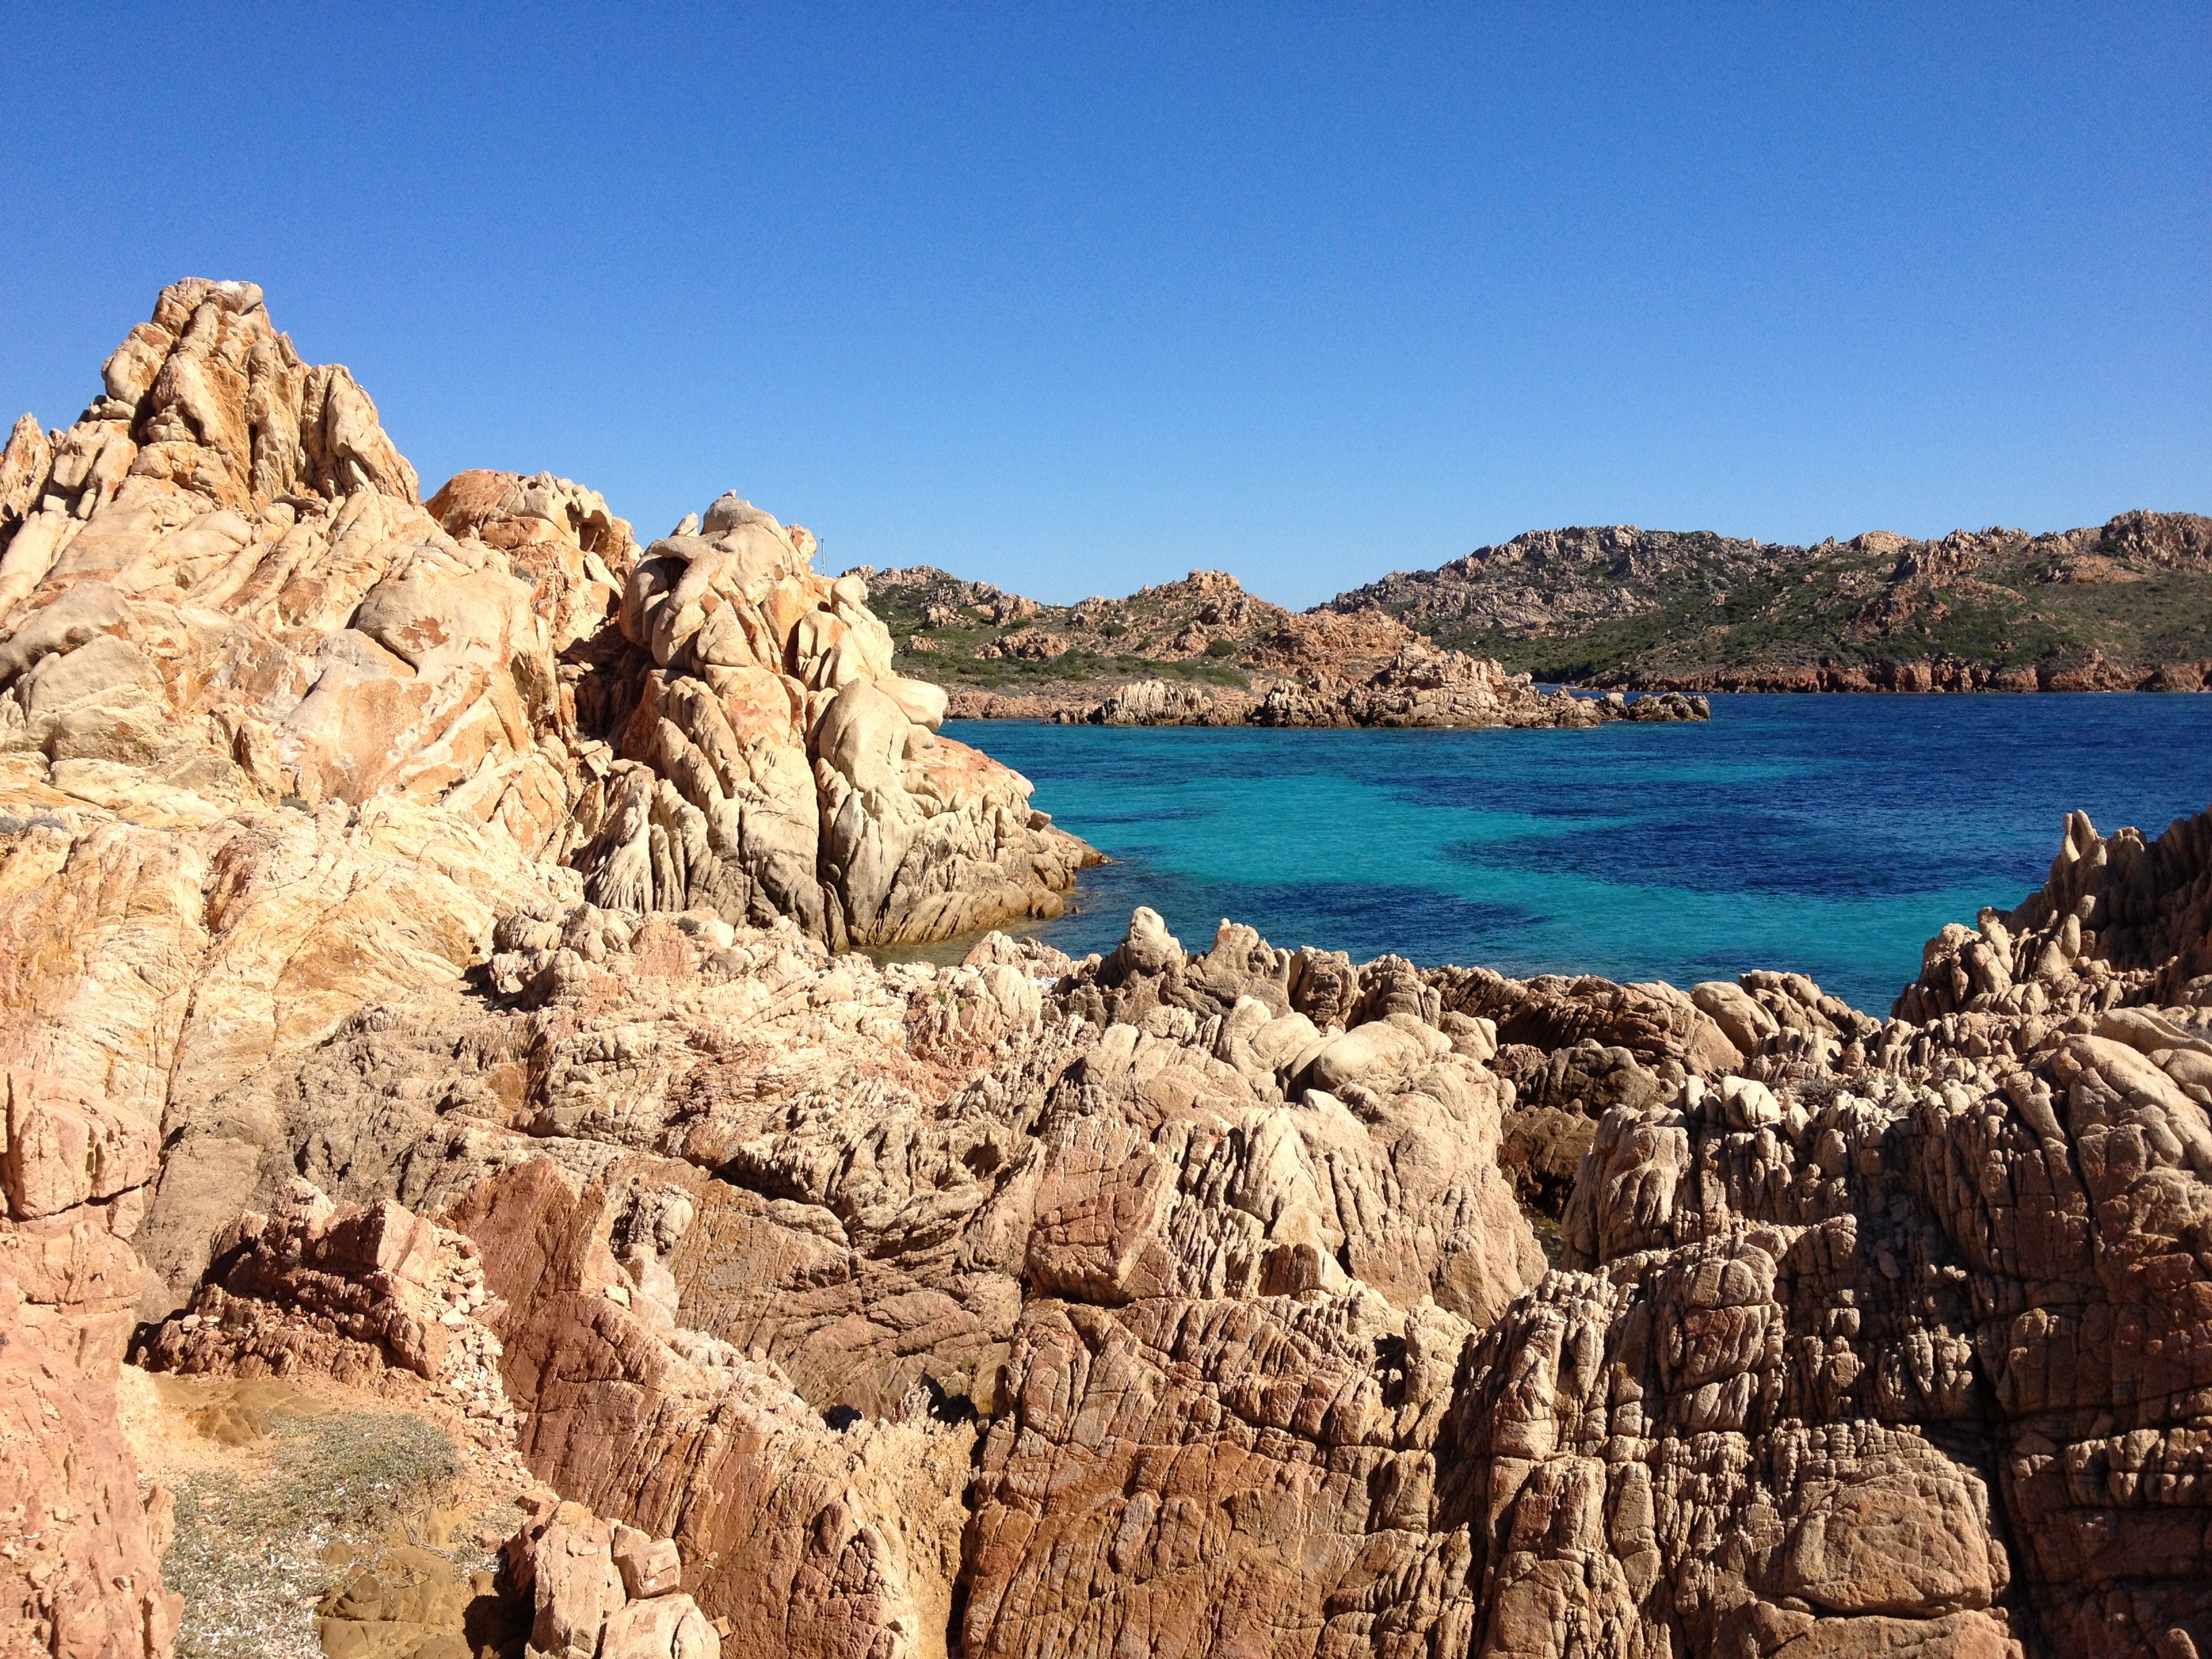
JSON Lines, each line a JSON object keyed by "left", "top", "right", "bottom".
{"left": 1458, "top": 814, "right": 2212, "bottom": 1654}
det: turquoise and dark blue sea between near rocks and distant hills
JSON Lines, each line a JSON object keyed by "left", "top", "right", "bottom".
{"left": 945, "top": 695, "right": 2212, "bottom": 1013}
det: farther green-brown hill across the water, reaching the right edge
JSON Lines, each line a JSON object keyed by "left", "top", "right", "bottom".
{"left": 1327, "top": 513, "right": 2212, "bottom": 690}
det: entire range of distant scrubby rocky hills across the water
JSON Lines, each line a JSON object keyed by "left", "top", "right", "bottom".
{"left": 854, "top": 513, "right": 2212, "bottom": 714}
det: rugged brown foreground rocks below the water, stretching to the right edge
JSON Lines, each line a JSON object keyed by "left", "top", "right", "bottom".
{"left": 99, "top": 796, "right": 2212, "bottom": 1657}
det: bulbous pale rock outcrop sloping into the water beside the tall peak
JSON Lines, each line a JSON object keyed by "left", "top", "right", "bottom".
{"left": 577, "top": 495, "right": 1095, "bottom": 947}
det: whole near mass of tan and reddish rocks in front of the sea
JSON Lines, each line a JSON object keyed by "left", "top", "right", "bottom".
{"left": 0, "top": 281, "right": 2212, "bottom": 1659}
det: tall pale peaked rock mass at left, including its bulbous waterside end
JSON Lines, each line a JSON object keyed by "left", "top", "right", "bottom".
{"left": 0, "top": 281, "right": 1095, "bottom": 1312}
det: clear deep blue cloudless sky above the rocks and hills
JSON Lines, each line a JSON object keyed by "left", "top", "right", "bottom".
{"left": 0, "top": 5, "right": 2212, "bottom": 604}
